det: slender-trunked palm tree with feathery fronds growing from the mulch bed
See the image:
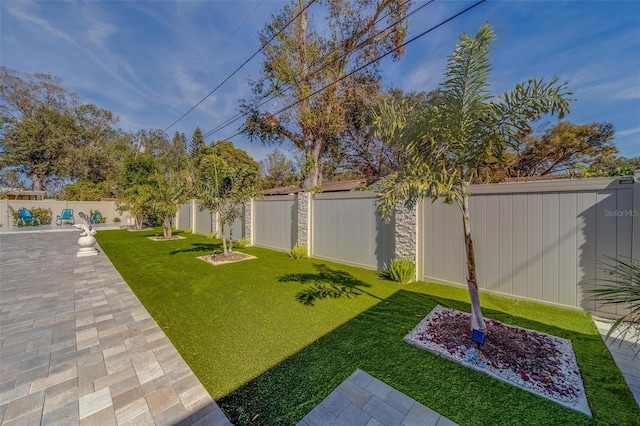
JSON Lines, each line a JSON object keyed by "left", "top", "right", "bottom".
{"left": 375, "top": 24, "right": 570, "bottom": 331}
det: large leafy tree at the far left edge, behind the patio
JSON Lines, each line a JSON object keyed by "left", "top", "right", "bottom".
{"left": 0, "top": 67, "right": 117, "bottom": 190}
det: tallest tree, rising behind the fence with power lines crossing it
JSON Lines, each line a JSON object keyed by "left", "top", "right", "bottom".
{"left": 240, "top": 0, "right": 412, "bottom": 189}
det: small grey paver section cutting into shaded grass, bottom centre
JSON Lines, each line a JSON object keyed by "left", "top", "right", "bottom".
{"left": 298, "top": 370, "right": 456, "bottom": 426}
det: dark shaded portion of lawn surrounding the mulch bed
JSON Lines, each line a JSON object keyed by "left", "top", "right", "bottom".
{"left": 217, "top": 290, "right": 640, "bottom": 426}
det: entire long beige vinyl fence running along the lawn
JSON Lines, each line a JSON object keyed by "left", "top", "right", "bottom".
{"left": 177, "top": 173, "right": 640, "bottom": 316}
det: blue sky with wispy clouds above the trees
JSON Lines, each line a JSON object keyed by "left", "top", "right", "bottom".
{"left": 0, "top": 0, "right": 640, "bottom": 160}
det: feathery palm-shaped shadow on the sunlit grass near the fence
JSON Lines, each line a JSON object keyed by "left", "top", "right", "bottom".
{"left": 278, "top": 264, "right": 383, "bottom": 306}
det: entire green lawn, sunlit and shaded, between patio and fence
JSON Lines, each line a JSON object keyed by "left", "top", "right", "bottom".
{"left": 96, "top": 231, "right": 640, "bottom": 425}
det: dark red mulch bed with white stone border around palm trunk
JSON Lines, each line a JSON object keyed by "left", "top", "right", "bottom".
{"left": 404, "top": 305, "right": 591, "bottom": 416}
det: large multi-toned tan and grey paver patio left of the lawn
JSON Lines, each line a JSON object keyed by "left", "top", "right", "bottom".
{"left": 0, "top": 230, "right": 231, "bottom": 426}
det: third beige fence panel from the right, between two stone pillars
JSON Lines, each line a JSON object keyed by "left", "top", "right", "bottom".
{"left": 253, "top": 195, "right": 298, "bottom": 250}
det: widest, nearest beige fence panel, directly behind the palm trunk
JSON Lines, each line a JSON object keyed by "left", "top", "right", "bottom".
{"left": 419, "top": 178, "right": 638, "bottom": 315}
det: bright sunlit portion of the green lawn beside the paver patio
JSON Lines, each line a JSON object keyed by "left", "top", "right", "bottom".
{"left": 97, "top": 231, "right": 400, "bottom": 398}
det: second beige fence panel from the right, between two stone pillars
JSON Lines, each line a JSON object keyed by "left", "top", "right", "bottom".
{"left": 311, "top": 192, "right": 395, "bottom": 269}
